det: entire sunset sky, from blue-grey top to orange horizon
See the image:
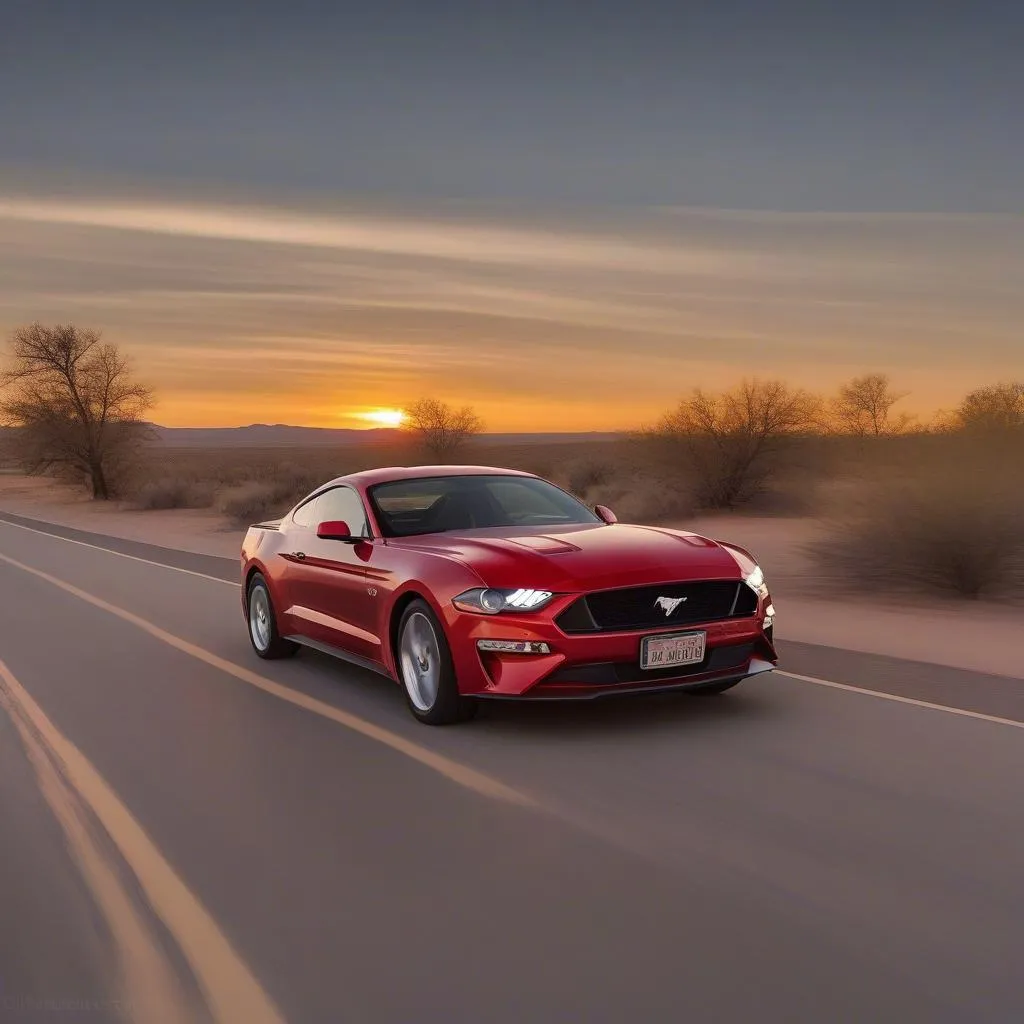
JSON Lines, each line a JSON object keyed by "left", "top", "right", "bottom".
{"left": 0, "top": 0, "right": 1024, "bottom": 430}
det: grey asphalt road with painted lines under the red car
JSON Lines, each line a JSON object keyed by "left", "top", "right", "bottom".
{"left": 0, "top": 515, "right": 1024, "bottom": 1024}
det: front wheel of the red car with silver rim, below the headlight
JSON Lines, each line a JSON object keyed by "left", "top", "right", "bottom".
{"left": 395, "top": 599, "right": 476, "bottom": 725}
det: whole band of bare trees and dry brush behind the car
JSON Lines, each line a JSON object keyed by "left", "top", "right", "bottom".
{"left": 0, "top": 325, "right": 1024, "bottom": 600}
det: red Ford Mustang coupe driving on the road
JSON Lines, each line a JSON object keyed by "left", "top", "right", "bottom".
{"left": 242, "top": 466, "right": 778, "bottom": 725}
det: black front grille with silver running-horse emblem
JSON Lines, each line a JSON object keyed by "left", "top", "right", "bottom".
{"left": 555, "top": 580, "right": 758, "bottom": 635}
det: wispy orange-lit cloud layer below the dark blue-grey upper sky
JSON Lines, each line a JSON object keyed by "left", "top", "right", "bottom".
{"left": 0, "top": 194, "right": 1024, "bottom": 429}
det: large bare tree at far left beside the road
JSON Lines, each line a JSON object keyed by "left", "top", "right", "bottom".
{"left": 0, "top": 324, "right": 153, "bottom": 500}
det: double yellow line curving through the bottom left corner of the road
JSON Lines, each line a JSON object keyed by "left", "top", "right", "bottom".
{"left": 0, "top": 662, "right": 285, "bottom": 1024}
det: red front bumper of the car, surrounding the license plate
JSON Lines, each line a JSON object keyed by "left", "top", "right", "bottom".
{"left": 449, "top": 599, "right": 778, "bottom": 700}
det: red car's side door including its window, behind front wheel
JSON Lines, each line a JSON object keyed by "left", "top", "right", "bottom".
{"left": 291, "top": 485, "right": 381, "bottom": 662}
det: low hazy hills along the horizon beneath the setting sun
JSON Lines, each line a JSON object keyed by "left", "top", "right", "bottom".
{"left": 146, "top": 423, "right": 621, "bottom": 447}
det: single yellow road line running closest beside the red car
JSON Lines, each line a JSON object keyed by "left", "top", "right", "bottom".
{"left": 0, "top": 554, "right": 537, "bottom": 807}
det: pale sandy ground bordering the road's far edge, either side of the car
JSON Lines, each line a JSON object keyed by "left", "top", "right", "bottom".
{"left": 0, "top": 474, "right": 1024, "bottom": 679}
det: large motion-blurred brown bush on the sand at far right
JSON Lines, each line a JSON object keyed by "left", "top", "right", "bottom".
{"left": 807, "top": 464, "right": 1024, "bottom": 599}
